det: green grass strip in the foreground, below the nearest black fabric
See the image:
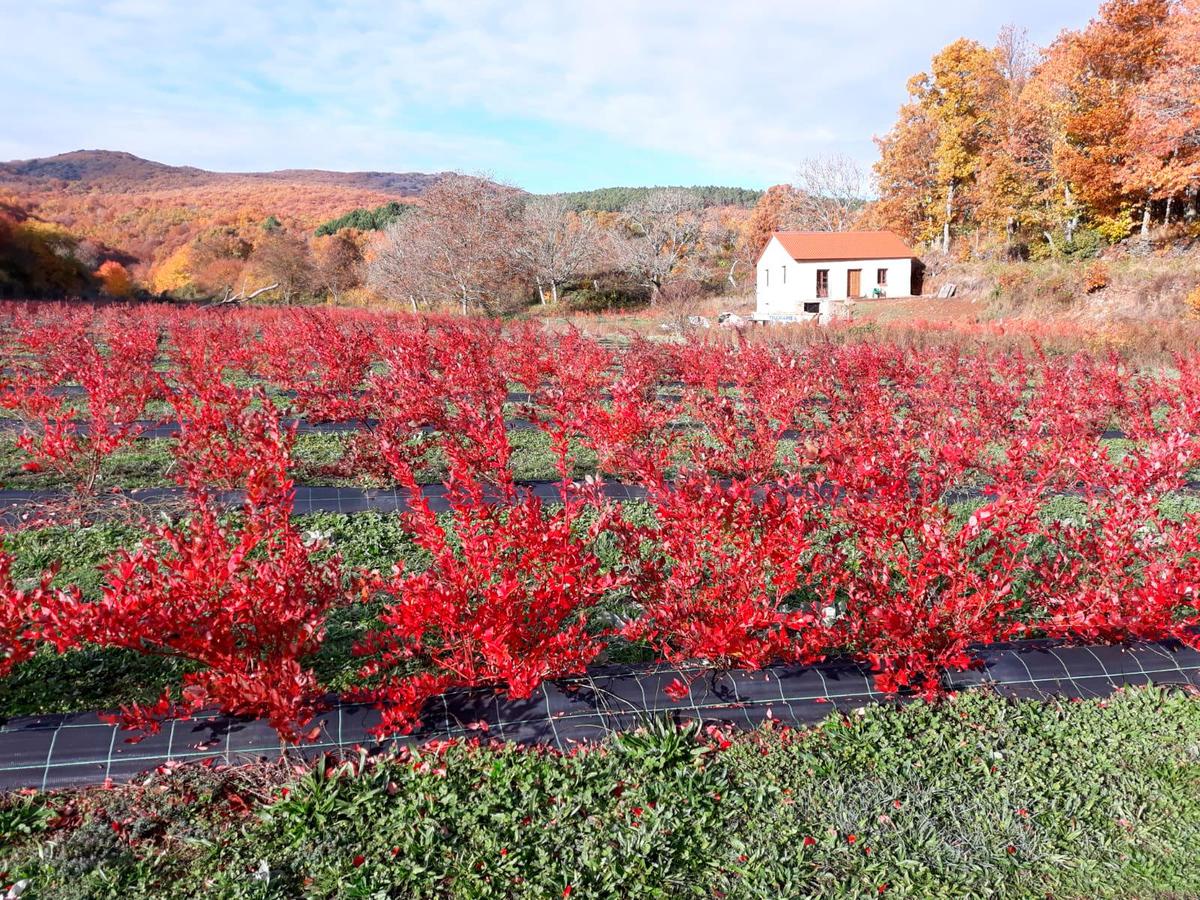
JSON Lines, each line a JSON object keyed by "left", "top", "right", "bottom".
{"left": 0, "top": 690, "right": 1200, "bottom": 898}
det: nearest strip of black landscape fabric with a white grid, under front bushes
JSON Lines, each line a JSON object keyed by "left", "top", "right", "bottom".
{"left": 0, "top": 641, "right": 1200, "bottom": 790}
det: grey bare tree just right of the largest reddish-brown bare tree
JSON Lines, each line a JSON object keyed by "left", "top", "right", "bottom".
{"left": 516, "top": 196, "right": 600, "bottom": 305}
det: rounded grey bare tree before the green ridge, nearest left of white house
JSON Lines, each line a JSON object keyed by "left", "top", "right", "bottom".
{"left": 616, "top": 187, "right": 703, "bottom": 304}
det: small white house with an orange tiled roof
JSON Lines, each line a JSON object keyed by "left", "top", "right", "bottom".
{"left": 755, "top": 232, "right": 914, "bottom": 324}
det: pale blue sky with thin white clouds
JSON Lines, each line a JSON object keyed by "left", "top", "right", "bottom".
{"left": 0, "top": 0, "right": 1099, "bottom": 192}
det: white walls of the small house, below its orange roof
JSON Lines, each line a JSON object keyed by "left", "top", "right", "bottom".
{"left": 755, "top": 238, "right": 912, "bottom": 322}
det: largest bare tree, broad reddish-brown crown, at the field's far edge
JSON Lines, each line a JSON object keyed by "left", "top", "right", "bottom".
{"left": 367, "top": 175, "right": 520, "bottom": 314}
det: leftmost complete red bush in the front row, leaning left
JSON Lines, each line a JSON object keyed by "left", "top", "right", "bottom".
{"left": 40, "top": 487, "right": 344, "bottom": 740}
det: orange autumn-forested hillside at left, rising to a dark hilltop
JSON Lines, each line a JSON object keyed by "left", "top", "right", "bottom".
{"left": 0, "top": 150, "right": 440, "bottom": 295}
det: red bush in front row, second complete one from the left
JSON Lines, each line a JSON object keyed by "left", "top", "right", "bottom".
{"left": 355, "top": 453, "right": 630, "bottom": 733}
